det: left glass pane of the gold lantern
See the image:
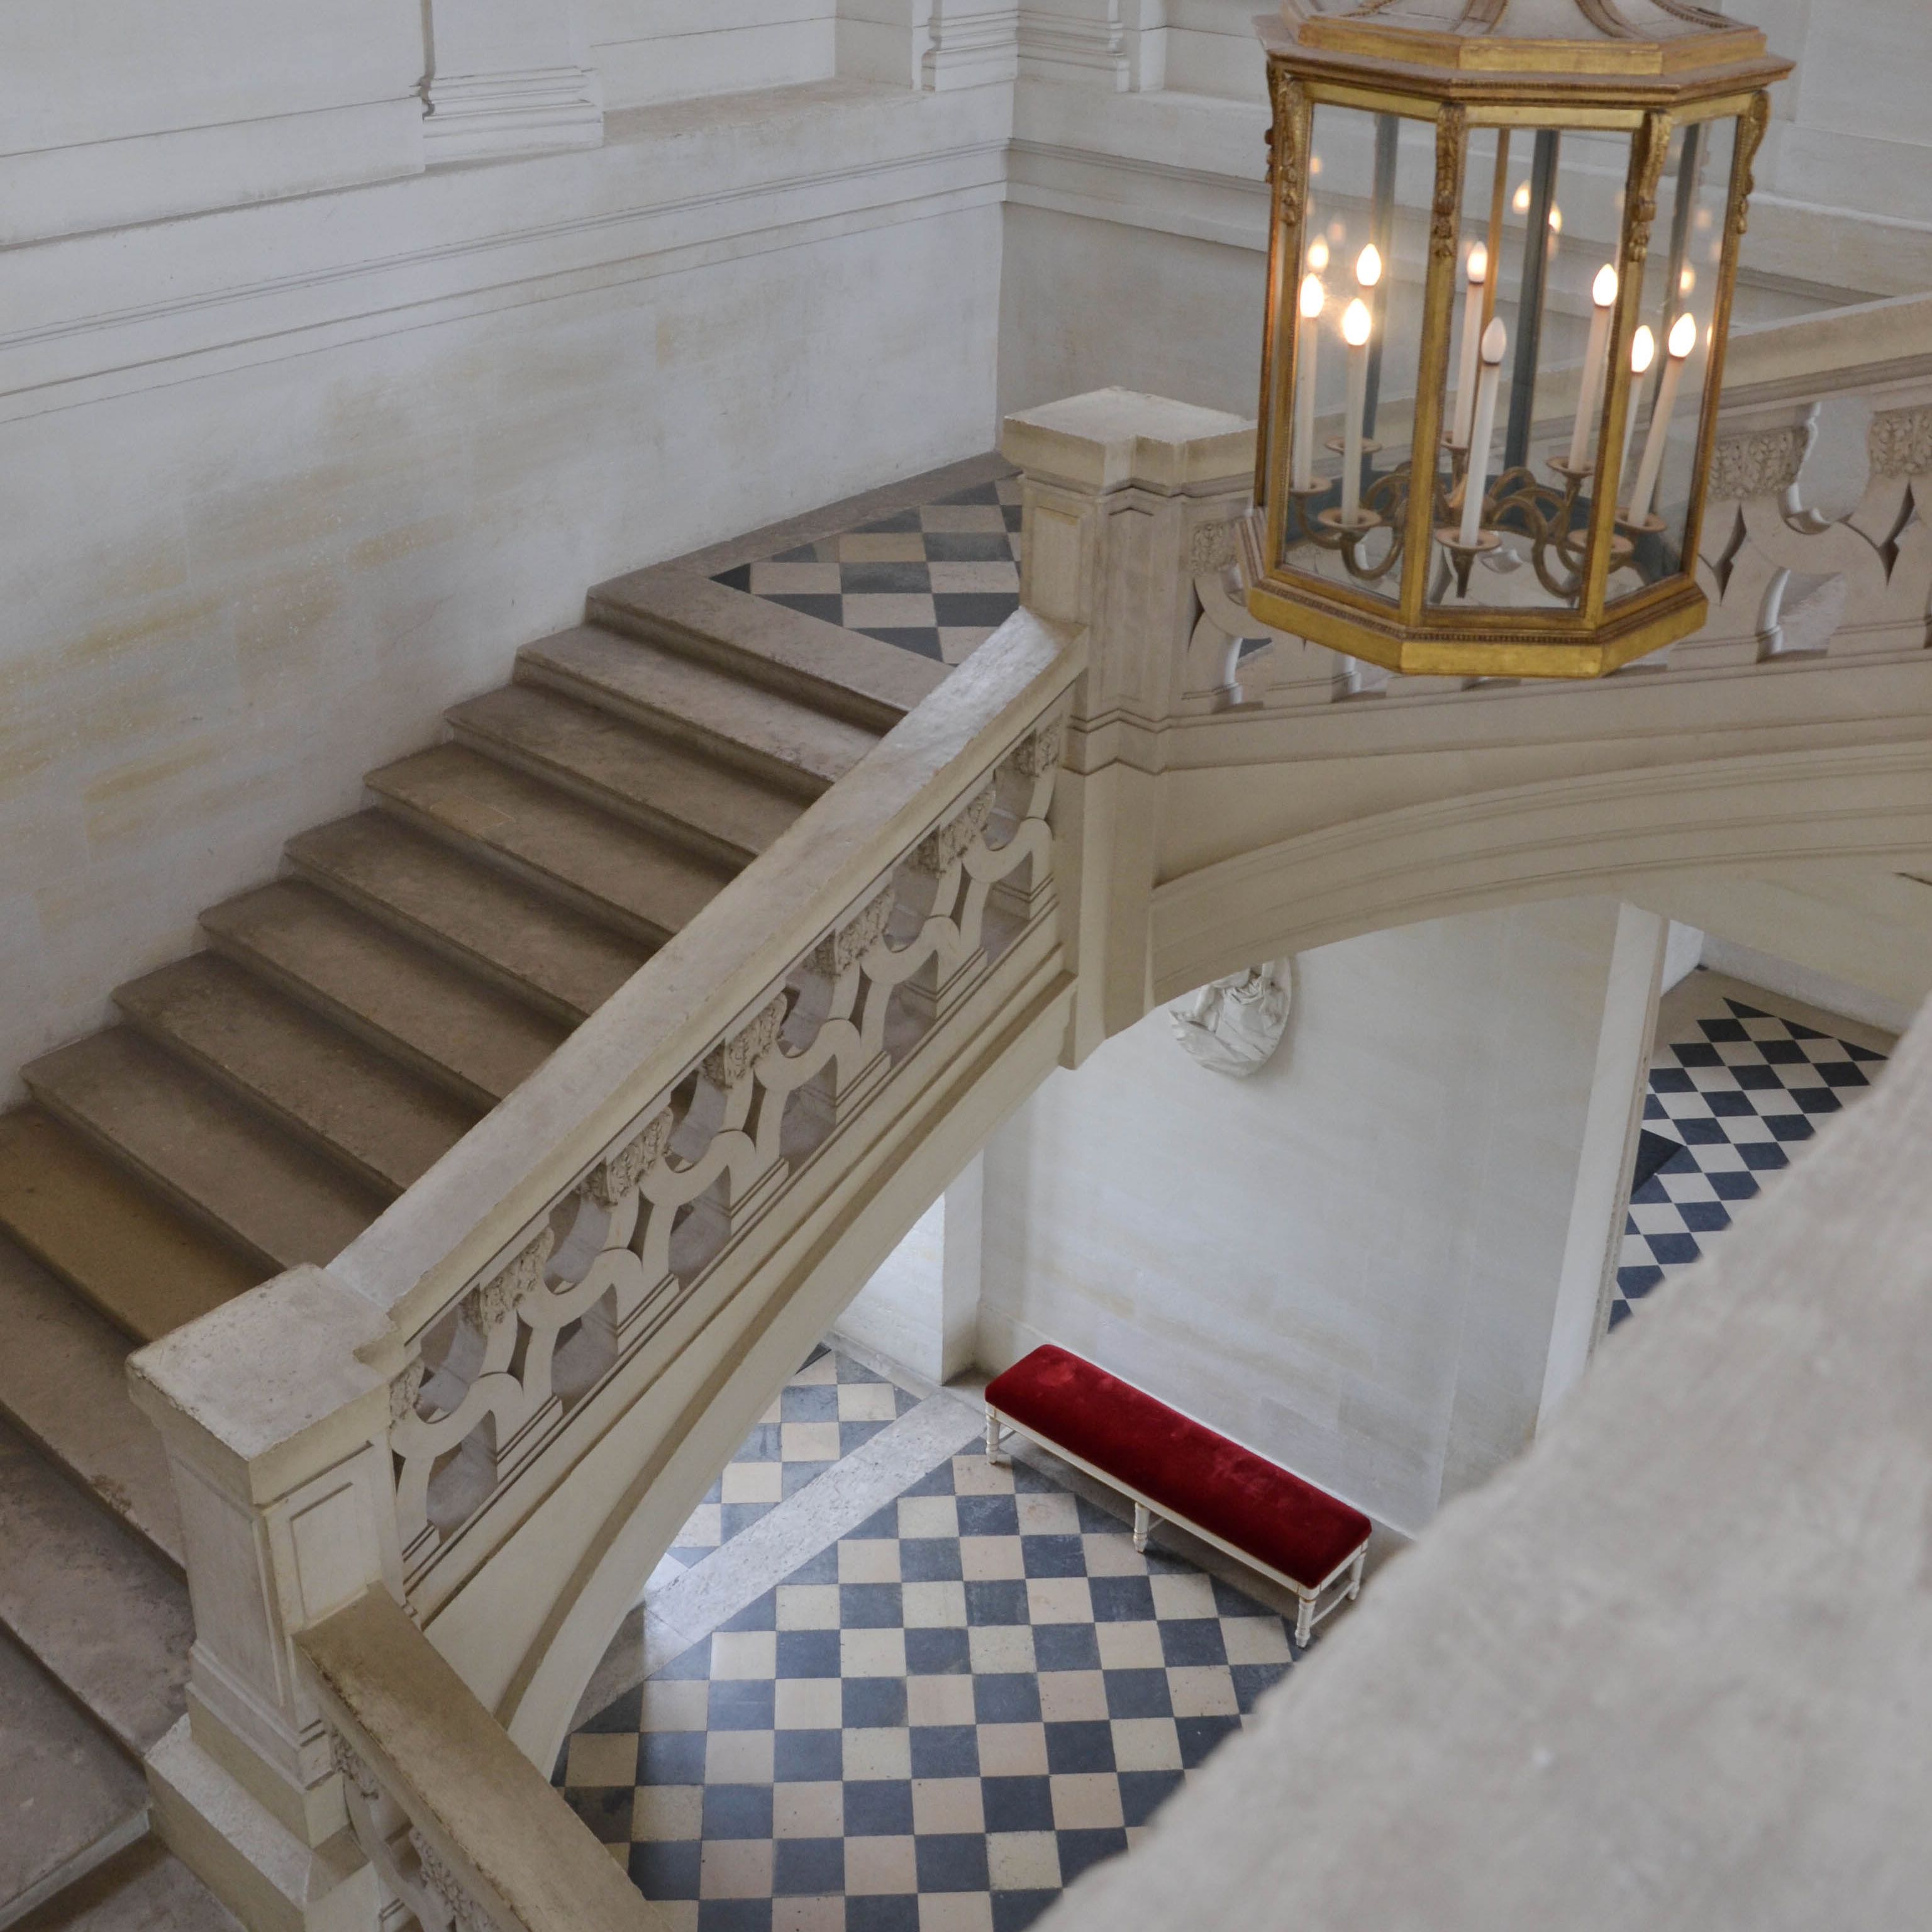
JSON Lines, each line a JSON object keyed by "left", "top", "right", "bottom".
{"left": 1281, "top": 101, "right": 1435, "bottom": 602}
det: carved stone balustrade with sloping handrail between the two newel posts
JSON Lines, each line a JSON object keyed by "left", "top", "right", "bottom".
{"left": 379, "top": 614, "right": 1078, "bottom": 1592}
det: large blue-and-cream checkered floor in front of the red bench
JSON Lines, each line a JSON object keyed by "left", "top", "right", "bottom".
{"left": 558, "top": 1455, "right": 1294, "bottom": 1932}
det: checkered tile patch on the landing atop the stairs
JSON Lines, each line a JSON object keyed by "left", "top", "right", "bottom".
{"left": 717, "top": 477, "right": 1020, "bottom": 665}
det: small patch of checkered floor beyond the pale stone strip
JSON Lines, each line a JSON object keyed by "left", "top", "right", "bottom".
{"left": 670, "top": 1345, "right": 919, "bottom": 1568}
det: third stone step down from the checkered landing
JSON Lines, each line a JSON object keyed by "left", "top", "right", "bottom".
{"left": 367, "top": 744, "right": 730, "bottom": 945}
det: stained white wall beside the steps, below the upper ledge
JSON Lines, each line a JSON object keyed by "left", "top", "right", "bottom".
{"left": 0, "top": 91, "right": 999, "bottom": 1092}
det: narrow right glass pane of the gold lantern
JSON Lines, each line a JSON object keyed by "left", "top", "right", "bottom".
{"left": 1609, "top": 118, "right": 1737, "bottom": 599}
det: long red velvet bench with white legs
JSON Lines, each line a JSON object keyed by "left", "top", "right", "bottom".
{"left": 985, "top": 1346, "right": 1370, "bottom": 1644}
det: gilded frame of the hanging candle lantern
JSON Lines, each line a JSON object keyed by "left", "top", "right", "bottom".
{"left": 1242, "top": 0, "right": 1791, "bottom": 678}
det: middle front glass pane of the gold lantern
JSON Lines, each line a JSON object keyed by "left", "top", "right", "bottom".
{"left": 1428, "top": 128, "right": 1631, "bottom": 611}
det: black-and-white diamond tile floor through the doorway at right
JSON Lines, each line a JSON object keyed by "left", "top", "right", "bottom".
{"left": 1609, "top": 999, "right": 1885, "bottom": 1327}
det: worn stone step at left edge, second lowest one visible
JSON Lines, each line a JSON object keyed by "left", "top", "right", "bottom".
{"left": 0, "top": 1631, "right": 147, "bottom": 1926}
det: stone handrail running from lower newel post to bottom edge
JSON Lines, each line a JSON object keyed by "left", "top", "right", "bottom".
{"left": 296, "top": 1590, "right": 665, "bottom": 1932}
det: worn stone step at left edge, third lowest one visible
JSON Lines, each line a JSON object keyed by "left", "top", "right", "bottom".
{"left": 0, "top": 1424, "right": 195, "bottom": 1756}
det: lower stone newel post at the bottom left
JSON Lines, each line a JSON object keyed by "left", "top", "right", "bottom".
{"left": 130, "top": 1267, "right": 415, "bottom": 1932}
